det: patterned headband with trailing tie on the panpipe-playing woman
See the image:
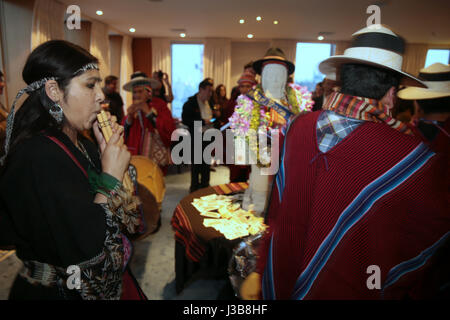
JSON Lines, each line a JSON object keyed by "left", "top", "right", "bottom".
{"left": 0, "top": 63, "right": 99, "bottom": 165}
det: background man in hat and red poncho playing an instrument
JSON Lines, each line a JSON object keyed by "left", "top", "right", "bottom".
{"left": 123, "top": 71, "right": 175, "bottom": 173}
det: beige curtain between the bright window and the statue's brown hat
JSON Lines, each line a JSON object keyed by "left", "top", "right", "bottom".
{"left": 203, "top": 39, "right": 231, "bottom": 94}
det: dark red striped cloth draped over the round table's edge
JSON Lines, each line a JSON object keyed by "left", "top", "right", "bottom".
{"left": 171, "top": 182, "right": 248, "bottom": 262}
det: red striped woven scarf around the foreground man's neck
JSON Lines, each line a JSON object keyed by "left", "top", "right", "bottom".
{"left": 322, "top": 92, "right": 413, "bottom": 135}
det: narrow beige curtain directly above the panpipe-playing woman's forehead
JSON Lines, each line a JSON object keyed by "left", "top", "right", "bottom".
{"left": 89, "top": 20, "right": 110, "bottom": 78}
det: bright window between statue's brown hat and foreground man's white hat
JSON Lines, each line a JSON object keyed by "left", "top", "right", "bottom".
{"left": 294, "top": 42, "right": 334, "bottom": 91}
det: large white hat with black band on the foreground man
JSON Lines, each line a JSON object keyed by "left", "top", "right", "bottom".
{"left": 319, "top": 24, "right": 426, "bottom": 87}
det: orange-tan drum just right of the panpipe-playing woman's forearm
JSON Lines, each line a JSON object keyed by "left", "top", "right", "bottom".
{"left": 131, "top": 156, "right": 166, "bottom": 210}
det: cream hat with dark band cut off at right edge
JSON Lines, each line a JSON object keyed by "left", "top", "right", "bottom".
{"left": 398, "top": 63, "right": 450, "bottom": 100}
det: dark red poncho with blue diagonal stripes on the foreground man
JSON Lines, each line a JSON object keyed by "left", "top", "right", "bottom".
{"left": 257, "top": 112, "right": 450, "bottom": 299}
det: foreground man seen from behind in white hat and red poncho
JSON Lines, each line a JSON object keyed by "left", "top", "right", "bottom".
{"left": 241, "top": 25, "right": 450, "bottom": 299}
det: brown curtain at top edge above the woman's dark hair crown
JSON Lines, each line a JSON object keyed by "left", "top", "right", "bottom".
{"left": 31, "top": 0, "right": 65, "bottom": 50}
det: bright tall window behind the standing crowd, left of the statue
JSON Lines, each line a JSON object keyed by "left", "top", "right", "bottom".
{"left": 172, "top": 44, "right": 204, "bottom": 118}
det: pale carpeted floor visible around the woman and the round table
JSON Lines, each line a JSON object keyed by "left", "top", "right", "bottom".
{"left": 0, "top": 166, "right": 229, "bottom": 300}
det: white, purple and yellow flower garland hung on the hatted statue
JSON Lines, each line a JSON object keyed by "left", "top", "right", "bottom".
{"left": 229, "top": 83, "right": 314, "bottom": 166}
